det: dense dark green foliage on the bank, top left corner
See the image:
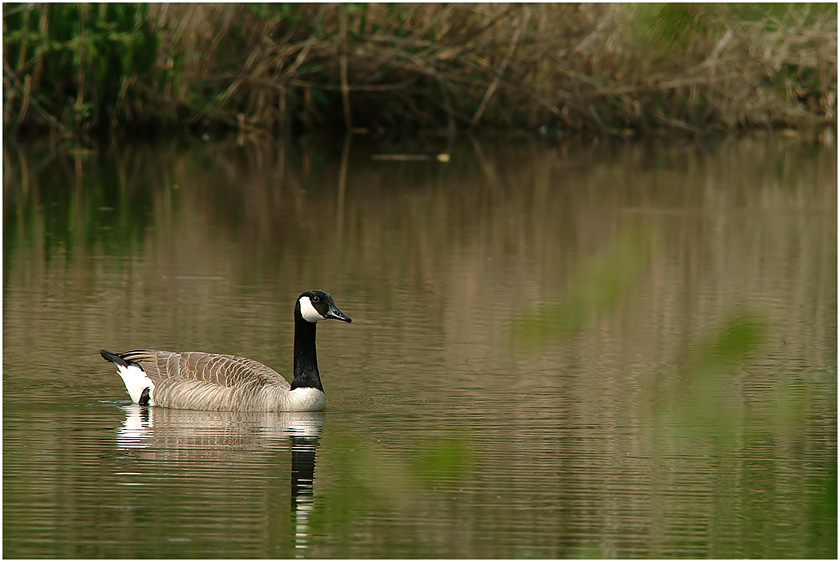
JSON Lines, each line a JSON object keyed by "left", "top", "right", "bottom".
{"left": 3, "top": 4, "right": 158, "bottom": 129}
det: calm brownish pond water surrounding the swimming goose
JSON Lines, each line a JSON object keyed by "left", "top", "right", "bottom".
{"left": 3, "top": 137, "right": 837, "bottom": 558}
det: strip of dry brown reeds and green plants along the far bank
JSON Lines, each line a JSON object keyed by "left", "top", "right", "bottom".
{"left": 3, "top": 4, "right": 837, "bottom": 139}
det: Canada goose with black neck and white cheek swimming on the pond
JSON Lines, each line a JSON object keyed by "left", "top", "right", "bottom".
{"left": 99, "top": 290, "right": 351, "bottom": 412}
